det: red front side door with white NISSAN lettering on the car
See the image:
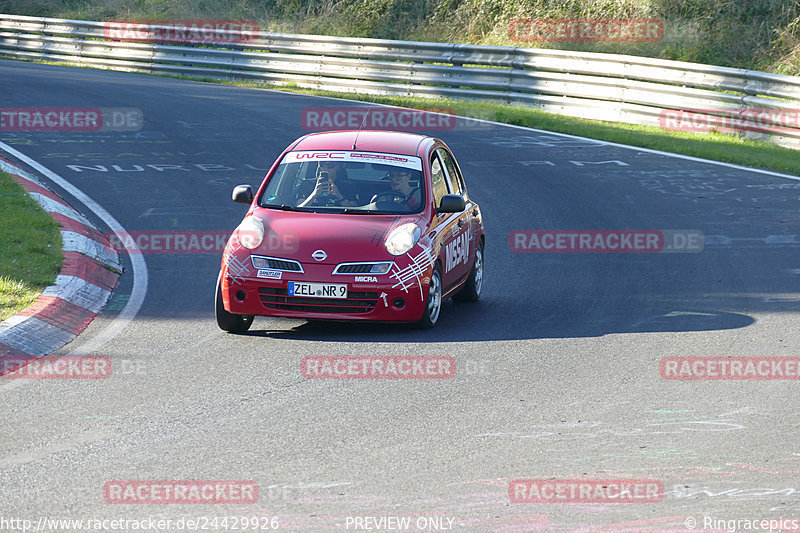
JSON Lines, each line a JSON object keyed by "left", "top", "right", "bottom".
{"left": 431, "top": 147, "right": 474, "bottom": 290}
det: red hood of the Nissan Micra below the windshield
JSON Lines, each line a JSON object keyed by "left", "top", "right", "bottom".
{"left": 251, "top": 208, "right": 426, "bottom": 264}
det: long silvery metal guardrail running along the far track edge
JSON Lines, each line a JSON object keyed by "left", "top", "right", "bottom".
{"left": 0, "top": 15, "right": 800, "bottom": 148}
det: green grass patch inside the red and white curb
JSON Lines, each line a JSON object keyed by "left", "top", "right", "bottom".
{"left": 0, "top": 172, "right": 63, "bottom": 321}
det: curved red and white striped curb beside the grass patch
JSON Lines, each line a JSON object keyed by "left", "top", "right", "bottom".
{"left": 0, "top": 158, "right": 122, "bottom": 366}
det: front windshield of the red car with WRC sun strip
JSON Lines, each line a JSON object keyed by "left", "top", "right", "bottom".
{"left": 258, "top": 151, "right": 425, "bottom": 214}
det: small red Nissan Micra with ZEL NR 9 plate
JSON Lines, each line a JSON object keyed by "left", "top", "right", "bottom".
{"left": 215, "top": 131, "right": 485, "bottom": 333}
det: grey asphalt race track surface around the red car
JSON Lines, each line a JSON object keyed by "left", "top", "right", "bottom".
{"left": 0, "top": 56, "right": 800, "bottom": 532}
